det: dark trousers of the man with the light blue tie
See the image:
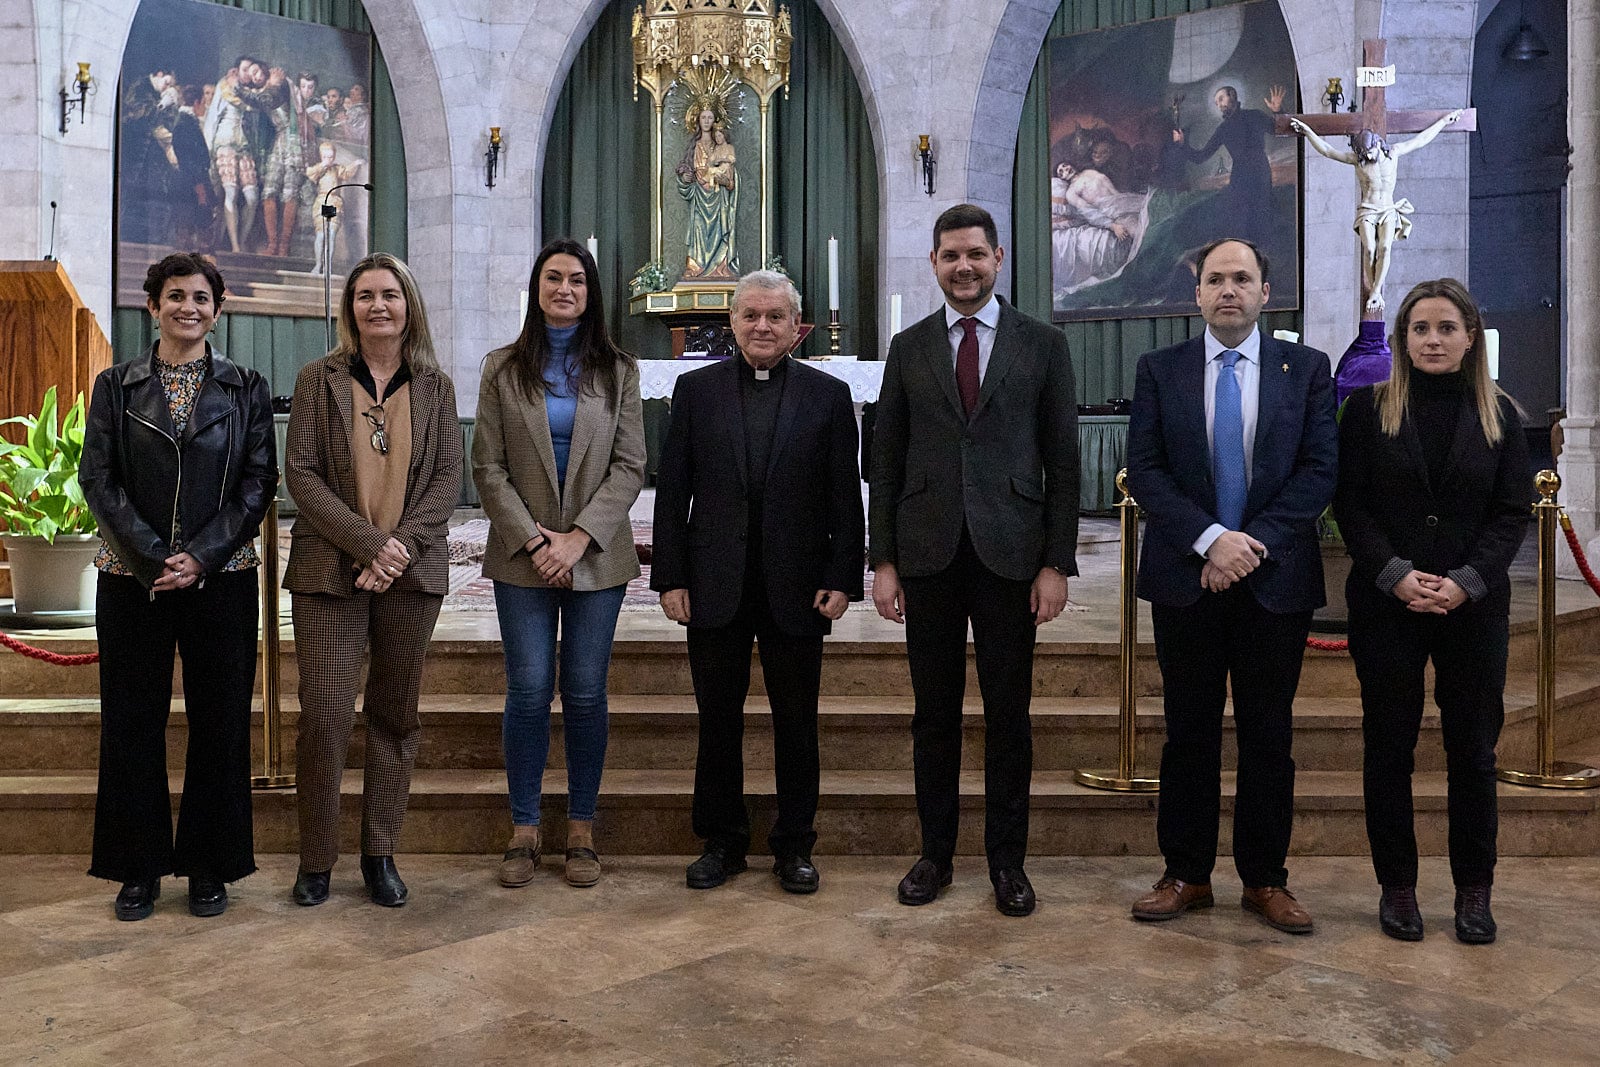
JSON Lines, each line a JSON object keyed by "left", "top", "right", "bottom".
{"left": 1150, "top": 584, "right": 1312, "bottom": 888}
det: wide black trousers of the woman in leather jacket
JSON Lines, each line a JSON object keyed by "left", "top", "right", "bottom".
{"left": 90, "top": 569, "right": 261, "bottom": 881}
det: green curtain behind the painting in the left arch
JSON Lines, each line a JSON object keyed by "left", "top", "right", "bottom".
{"left": 110, "top": 0, "right": 406, "bottom": 394}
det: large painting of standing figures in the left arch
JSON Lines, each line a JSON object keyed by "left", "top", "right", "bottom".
{"left": 117, "top": 0, "right": 373, "bottom": 315}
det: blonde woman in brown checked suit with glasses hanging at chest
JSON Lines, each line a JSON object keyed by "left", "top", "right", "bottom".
{"left": 283, "top": 253, "right": 461, "bottom": 907}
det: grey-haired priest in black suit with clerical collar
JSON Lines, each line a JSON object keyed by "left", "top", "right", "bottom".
{"left": 650, "top": 270, "right": 864, "bottom": 893}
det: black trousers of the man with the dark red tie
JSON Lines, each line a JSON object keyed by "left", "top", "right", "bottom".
{"left": 902, "top": 531, "right": 1037, "bottom": 872}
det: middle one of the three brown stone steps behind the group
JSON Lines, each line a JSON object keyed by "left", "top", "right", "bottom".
{"left": 0, "top": 656, "right": 1600, "bottom": 773}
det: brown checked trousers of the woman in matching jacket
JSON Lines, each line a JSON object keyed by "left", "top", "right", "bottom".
{"left": 294, "top": 589, "right": 443, "bottom": 870}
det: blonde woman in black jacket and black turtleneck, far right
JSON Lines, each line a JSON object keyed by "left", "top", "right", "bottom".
{"left": 1333, "top": 278, "right": 1533, "bottom": 944}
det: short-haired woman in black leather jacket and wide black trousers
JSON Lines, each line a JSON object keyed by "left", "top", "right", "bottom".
{"left": 78, "top": 253, "right": 278, "bottom": 920}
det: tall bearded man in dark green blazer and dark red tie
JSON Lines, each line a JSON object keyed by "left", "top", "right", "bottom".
{"left": 869, "top": 203, "right": 1078, "bottom": 915}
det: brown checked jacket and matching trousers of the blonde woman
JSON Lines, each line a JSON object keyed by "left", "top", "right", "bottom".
{"left": 283, "top": 357, "right": 462, "bottom": 870}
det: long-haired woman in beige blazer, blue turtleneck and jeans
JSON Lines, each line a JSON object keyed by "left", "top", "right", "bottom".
{"left": 472, "top": 238, "right": 645, "bottom": 886}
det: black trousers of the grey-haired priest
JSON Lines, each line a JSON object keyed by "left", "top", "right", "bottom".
{"left": 688, "top": 587, "right": 822, "bottom": 857}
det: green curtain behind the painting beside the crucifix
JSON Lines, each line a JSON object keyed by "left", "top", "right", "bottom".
{"left": 1011, "top": 0, "right": 1302, "bottom": 403}
